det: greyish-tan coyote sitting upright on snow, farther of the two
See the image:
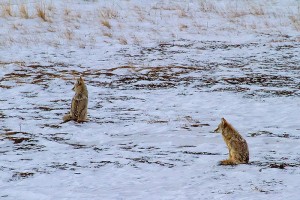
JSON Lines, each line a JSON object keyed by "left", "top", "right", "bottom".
{"left": 63, "top": 77, "right": 88, "bottom": 122}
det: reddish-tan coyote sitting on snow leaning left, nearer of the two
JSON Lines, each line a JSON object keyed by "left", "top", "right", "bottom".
{"left": 214, "top": 118, "right": 249, "bottom": 165}
